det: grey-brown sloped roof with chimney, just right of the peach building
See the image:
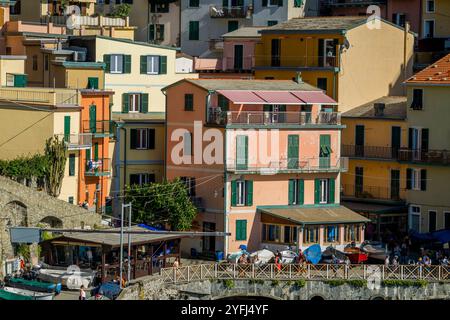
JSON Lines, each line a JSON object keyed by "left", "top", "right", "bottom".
{"left": 342, "top": 96, "right": 407, "bottom": 120}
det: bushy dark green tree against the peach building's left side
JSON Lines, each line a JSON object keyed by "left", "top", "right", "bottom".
{"left": 125, "top": 179, "right": 197, "bottom": 231}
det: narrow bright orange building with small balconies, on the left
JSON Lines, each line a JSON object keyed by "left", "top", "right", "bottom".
{"left": 78, "top": 90, "right": 114, "bottom": 212}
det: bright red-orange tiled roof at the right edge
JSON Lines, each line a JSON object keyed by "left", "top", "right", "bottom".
{"left": 406, "top": 54, "right": 450, "bottom": 84}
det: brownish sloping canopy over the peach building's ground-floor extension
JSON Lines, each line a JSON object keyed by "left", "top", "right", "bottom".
{"left": 257, "top": 206, "right": 370, "bottom": 225}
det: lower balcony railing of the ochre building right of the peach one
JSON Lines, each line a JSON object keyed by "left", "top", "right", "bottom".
{"left": 341, "top": 184, "right": 405, "bottom": 201}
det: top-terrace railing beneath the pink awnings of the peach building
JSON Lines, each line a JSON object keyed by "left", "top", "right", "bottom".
{"left": 208, "top": 108, "right": 341, "bottom": 126}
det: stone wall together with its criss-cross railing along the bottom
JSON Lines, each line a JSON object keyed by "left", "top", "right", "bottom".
{"left": 119, "top": 264, "right": 450, "bottom": 300}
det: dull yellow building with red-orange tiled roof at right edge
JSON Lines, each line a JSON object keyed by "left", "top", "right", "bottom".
{"left": 399, "top": 55, "right": 450, "bottom": 232}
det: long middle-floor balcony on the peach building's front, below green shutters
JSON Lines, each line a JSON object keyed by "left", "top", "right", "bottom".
{"left": 226, "top": 157, "right": 348, "bottom": 175}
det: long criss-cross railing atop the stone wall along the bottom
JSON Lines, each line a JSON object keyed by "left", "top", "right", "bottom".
{"left": 160, "top": 263, "right": 450, "bottom": 283}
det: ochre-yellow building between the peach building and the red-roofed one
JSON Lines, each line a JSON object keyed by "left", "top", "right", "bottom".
{"left": 341, "top": 96, "right": 408, "bottom": 240}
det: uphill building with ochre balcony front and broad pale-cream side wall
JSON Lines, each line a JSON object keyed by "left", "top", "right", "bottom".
{"left": 254, "top": 16, "right": 414, "bottom": 112}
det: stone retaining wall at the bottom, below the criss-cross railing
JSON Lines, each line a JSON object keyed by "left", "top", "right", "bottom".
{"left": 119, "top": 276, "right": 450, "bottom": 300}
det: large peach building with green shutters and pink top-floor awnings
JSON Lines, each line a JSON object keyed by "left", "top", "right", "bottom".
{"left": 162, "top": 78, "right": 368, "bottom": 255}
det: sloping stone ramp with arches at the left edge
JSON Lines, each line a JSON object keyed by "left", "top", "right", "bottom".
{"left": 0, "top": 176, "right": 101, "bottom": 260}
